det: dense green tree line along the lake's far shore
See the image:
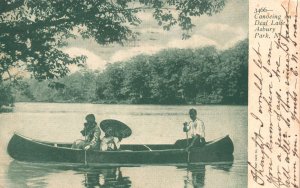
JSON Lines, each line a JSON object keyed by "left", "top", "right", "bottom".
{"left": 6, "top": 39, "right": 248, "bottom": 104}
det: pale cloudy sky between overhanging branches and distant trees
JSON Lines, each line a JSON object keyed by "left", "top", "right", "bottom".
{"left": 63, "top": 0, "right": 249, "bottom": 72}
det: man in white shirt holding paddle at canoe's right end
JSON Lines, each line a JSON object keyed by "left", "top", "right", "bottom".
{"left": 183, "top": 108, "right": 205, "bottom": 150}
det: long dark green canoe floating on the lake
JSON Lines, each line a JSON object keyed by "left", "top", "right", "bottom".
{"left": 7, "top": 133, "right": 234, "bottom": 165}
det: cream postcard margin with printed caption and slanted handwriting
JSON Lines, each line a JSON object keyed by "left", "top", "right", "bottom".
{"left": 248, "top": 0, "right": 300, "bottom": 188}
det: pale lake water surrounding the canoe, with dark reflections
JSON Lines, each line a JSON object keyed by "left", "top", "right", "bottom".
{"left": 0, "top": 103, "right": 248, "bottom": 188}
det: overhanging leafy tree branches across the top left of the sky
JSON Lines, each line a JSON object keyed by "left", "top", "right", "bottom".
{"left": 0, "top": 0, "right": 225, "bottom": 80}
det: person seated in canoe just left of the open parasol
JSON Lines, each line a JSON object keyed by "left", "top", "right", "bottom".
{"left": 72, "top": 114, "right": 101, "bottom": 150}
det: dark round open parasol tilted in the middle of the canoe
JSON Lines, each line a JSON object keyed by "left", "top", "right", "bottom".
{"left": 100, "top": 119, "right": 132, "bottom": 138}
